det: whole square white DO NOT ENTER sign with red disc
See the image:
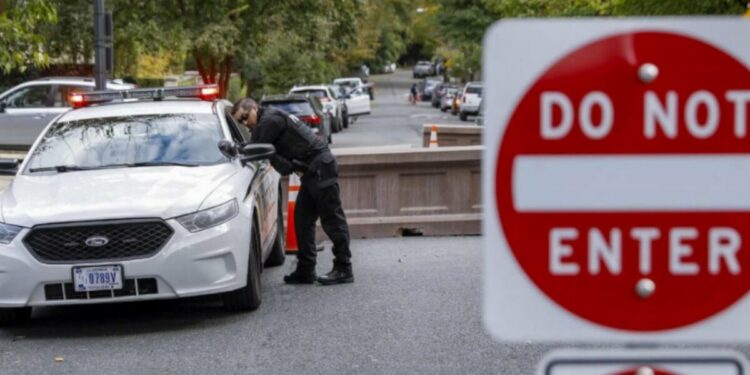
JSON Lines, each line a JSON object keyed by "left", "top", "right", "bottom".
{"left": 484, "top": 18, "right": 750, "bottom": 340}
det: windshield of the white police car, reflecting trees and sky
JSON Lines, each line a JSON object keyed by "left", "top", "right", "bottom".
{"left": 28, "top": 113, "right": 227, "bottom": 173}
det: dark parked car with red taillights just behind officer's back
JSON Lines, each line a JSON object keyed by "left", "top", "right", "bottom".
{"left": 260, "top": 94, "right": 333, "bottom": 143}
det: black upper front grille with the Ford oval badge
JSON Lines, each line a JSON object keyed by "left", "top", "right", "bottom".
{"left": 24, "top": 220, "right": 174, "bottom": 263}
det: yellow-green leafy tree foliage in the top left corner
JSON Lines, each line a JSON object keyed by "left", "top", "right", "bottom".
{"left": 0, "top": 0, "right": 57, "bottom": 73}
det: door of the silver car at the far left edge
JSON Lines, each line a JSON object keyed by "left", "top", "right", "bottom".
{"left": 0, "top": 84, "right": 55, "bottom": 148}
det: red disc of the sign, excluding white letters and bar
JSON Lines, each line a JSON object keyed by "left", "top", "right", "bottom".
{"left": 495, "top": 32, "right": 750, "bottom": 332}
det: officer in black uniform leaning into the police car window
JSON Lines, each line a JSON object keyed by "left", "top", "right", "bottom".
{"left": 232, "top": 98, "right": 354, "bottom": 285}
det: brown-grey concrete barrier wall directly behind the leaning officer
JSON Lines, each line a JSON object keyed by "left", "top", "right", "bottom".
{"left": 284, "top": 146, "right": 482, "bottom": 238}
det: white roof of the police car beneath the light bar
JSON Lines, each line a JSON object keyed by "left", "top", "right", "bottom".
{"left": 59, "top": 99, "right": 215, "bottom": 122}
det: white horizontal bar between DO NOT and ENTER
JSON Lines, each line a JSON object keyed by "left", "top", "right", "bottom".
{"left": 512, "top": 155, "right": 750, "bottom": 212}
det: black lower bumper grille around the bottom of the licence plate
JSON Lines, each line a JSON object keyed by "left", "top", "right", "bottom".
{"left": 44, "top": 278, "right": 159, "bottom": 301}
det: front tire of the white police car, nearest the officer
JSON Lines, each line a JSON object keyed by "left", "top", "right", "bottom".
{"left": 221, "top": 220, "right": 261, "bottom": 311}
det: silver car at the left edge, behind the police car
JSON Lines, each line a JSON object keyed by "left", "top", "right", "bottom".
{"left": 0, "top": 77, "right": 134, "bottom": 149}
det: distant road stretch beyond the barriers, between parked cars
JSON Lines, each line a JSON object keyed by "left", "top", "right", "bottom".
{"left": 332, "top": 70, "right": 468, "bottom": 148}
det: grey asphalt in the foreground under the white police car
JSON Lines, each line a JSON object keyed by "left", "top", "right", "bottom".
{"left": 0, "top": 237, "right": 543, "bottom": 374}
